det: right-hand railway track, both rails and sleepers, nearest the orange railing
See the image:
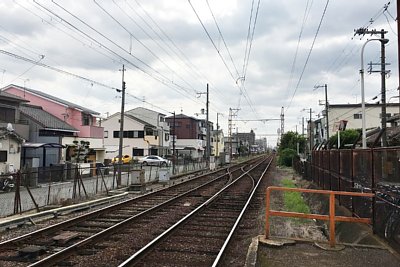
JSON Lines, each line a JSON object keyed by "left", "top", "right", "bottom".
{"left": 119, "top": 158, "right": 272, "bottom": 267}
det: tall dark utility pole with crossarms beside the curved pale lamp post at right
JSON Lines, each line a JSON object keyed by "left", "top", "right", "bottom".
{"left": 355, "top": 28, "right": 388, "bottom": 147}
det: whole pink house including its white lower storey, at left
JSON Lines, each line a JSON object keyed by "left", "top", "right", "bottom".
{"left": 2, "top": 84, "right": 105, "bottom": 162}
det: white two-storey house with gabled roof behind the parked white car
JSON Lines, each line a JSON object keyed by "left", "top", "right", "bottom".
{"left": 102, "top": 110, "right": 169, "bottom": 158}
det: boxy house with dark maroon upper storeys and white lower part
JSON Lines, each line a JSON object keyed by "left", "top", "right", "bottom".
{"left": 165, "top": 114, "right": 211, "bottom": 158}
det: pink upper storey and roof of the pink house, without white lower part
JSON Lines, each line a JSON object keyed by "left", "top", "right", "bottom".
{"left": 2, "top": 84, "right": 103, "bottom": 139}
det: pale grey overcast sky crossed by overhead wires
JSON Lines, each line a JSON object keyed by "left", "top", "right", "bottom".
{"left": 0, "top": 0, "right": 399, "bottom": 145}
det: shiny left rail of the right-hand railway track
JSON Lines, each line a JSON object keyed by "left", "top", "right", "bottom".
{"left": 118, "top": 156, "right": 265, "bottom": 267}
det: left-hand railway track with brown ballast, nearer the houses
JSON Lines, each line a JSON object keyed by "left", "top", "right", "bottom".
{"left": 0, "top": 156, "right": 272, "bottom": 266}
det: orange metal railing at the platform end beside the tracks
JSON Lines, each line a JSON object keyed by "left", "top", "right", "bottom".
{"left": 265, "top": 186, "right": 375, "bottom": 247}
